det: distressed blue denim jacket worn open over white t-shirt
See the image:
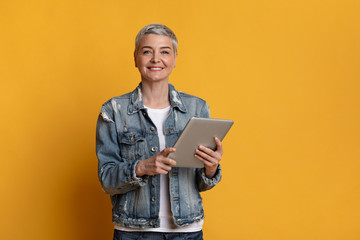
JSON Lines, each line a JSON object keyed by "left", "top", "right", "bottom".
{"left": 96, "top": 83, "right": 221, "bottom": 228}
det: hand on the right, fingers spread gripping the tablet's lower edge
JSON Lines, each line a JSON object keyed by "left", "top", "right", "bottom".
{"left": 195, "top": 137, "right": 224, "bottom": 178}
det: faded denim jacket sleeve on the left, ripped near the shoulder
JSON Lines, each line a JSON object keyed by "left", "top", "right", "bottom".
{"left": 96, "top": 104, "right": 148, "bottom": 195}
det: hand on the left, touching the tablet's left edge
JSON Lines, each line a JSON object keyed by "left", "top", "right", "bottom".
{"left": 135, "top": 148, "right": 176, "bottom": 177}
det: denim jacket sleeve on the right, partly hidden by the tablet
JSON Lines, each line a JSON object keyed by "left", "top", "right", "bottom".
{"left": 196, "top": 102, "right": 222, "bottom": 192}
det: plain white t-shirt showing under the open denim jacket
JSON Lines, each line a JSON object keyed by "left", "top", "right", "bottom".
{"left": 115, "top": 106, "right": 204, "bottom": 232}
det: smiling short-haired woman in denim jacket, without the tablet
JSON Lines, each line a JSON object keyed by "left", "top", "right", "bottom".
{"left": 96, "top": 24, "right": 223, "bottom": 239}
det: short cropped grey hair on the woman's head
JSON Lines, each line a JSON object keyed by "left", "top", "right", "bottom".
{"left": 135, "top": 23, "right": 178, "bottom": 55}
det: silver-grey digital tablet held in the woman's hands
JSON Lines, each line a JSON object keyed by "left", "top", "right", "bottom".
{"left": 168, "top": 117, "right": 234, "bottom": 168}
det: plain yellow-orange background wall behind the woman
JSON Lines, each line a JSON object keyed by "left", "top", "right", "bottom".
{"left": 0, "top": 0, "right": 360, "bottom": 240}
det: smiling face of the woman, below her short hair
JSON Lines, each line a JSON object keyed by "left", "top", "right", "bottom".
{"left": 134, "top": 34, "right": 176, "bottom": 82}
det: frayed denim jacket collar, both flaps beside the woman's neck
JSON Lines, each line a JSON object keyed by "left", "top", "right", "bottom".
{"left": 128, "top": 83, "right": 186, "bottom": 114}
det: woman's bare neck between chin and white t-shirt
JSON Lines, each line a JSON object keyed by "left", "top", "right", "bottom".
{"left": 141, "top": 81, "right": 170, "bottom": 109}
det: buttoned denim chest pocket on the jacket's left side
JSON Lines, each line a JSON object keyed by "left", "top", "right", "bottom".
{"left": 119, "top": 131, "right": 145, "bottom": 160}
